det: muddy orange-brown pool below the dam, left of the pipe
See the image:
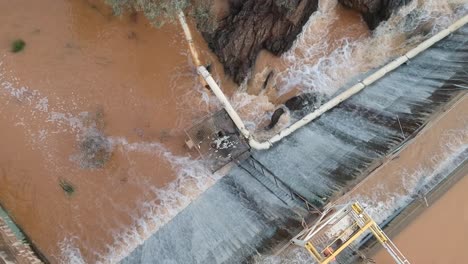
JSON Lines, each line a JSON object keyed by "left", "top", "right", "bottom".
{"left": 0, "top": 0, "right": 368, "bottom": 263}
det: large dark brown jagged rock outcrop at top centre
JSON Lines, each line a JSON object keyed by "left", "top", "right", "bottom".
{"left": 199, "top": 0, "right": 318, "bottom": 83}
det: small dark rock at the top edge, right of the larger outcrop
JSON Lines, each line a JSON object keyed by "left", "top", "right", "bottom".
{"left": 338, "top": 0, "right": 411, "bottom": 30}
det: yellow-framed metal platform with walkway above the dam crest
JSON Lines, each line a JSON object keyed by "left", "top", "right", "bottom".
{"left": 292, "top": 202, "right": 410, "bottom": 264}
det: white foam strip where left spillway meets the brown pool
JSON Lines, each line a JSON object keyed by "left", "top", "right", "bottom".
{"left": 90, "top": 138, "right": 221, "bottom": 263}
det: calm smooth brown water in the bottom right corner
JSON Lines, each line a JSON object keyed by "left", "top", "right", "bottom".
{"left": 373, "top": 169, "right": 468, "bottom": 264}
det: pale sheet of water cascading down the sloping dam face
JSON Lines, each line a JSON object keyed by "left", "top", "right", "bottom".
{"left": 122, "top": 17, "right": 468, "bottom": 263}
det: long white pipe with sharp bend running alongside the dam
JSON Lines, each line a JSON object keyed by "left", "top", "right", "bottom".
{"left": 184, "top": 15, "right": 468, "bottom": 150}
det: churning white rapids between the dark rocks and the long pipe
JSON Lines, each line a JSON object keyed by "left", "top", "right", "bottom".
{"left": 277, "top": 0, "right": 464, "bottom": 95}
